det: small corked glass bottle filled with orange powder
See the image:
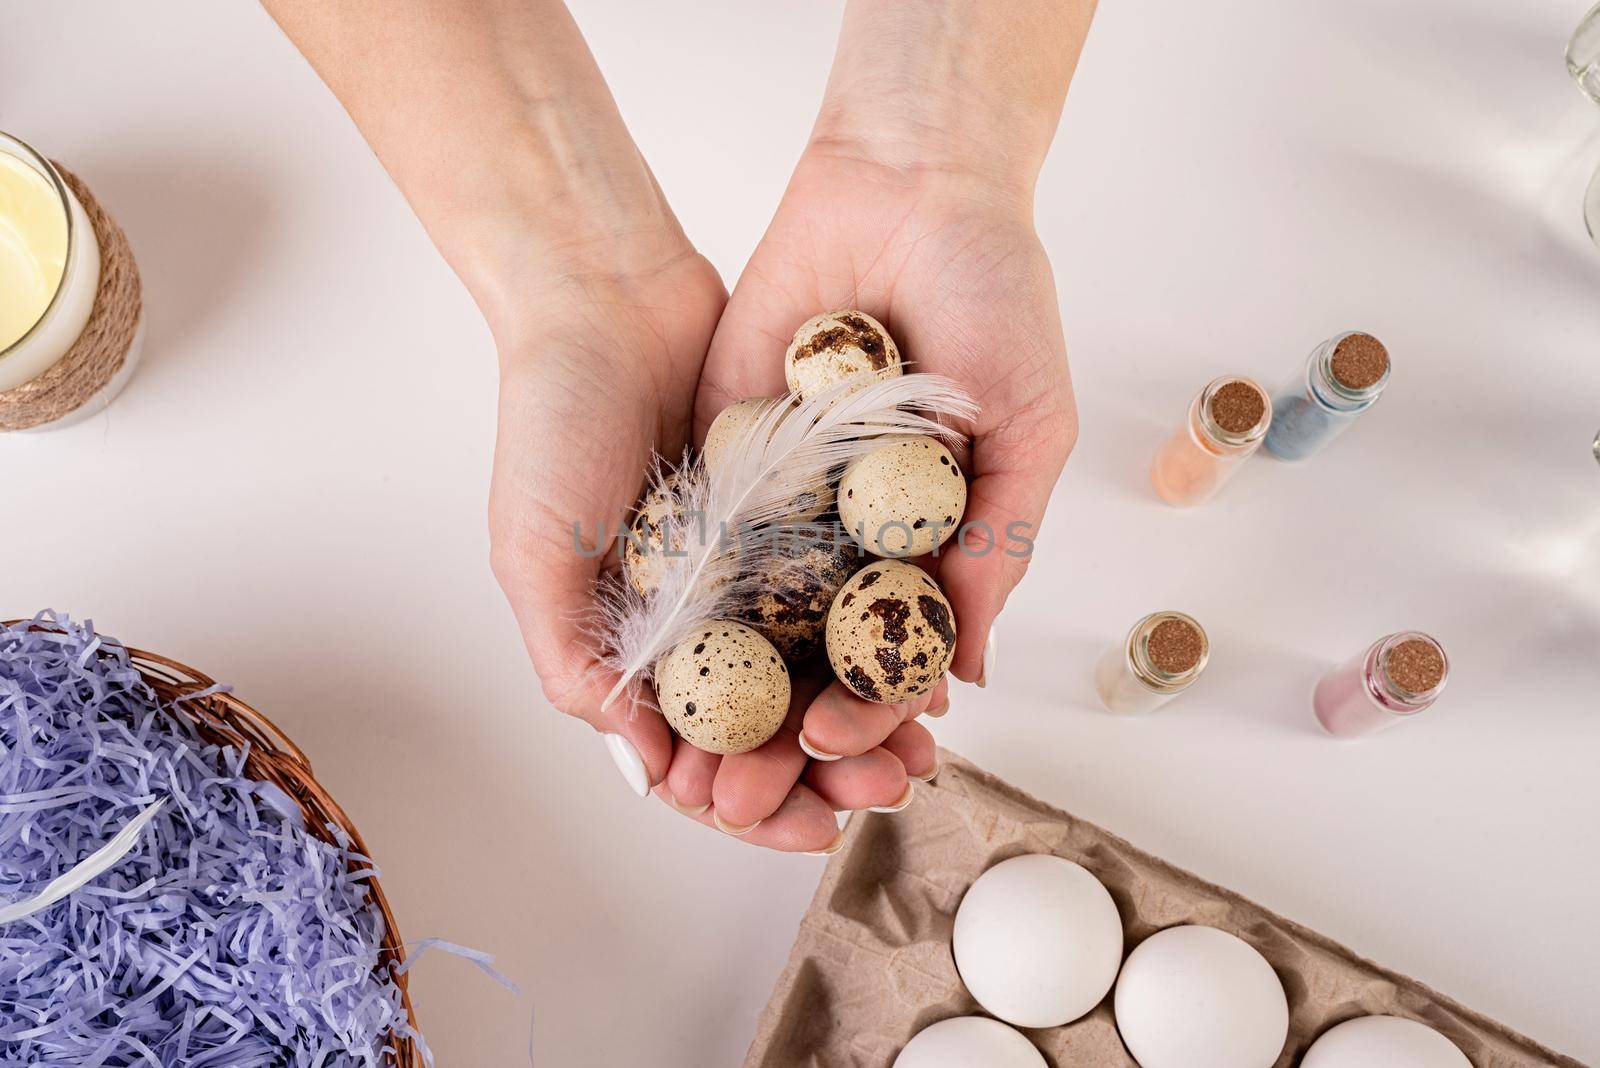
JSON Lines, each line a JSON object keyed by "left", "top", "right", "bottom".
{"left": 1150, "top": 376, "right": 1272, "bottom": 508}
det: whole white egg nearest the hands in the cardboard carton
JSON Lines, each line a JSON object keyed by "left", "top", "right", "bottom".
{"left": 952, "top": 854, "right": 1122, "bottom": 1026}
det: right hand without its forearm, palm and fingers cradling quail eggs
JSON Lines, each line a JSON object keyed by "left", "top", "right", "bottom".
{"left": 684, "top": 144, "right": 1077, "bottom": 847}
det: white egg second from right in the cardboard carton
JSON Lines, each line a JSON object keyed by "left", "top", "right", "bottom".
{"left": 1114, "top": 926, "right": 1290, "bottom": 1068}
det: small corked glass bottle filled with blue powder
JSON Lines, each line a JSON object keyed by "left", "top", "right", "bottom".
{"left": 1267, "top": 331, "right": 1389, "bottom": 460}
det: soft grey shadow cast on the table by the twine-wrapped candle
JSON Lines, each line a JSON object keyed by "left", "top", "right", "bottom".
{"left": 67, "top": 155, "right": 272, "bottom": 368}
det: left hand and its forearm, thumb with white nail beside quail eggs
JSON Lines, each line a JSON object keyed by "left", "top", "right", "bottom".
{"left": 267, "top": 0, "right": 857, "bottom": 849}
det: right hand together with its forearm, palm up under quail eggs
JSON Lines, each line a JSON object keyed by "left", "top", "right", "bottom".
{"left": 681, "top": 0, "right": 1093, "bottom": 836}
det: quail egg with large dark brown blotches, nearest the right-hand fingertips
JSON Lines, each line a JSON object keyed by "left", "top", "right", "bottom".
{"left": 827, "top": 560, "right": 955, "bottom": 703}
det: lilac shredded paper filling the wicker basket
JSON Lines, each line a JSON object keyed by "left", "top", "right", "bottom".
{"left": 0, "top": 614, "right": 432, "bottom": 1068}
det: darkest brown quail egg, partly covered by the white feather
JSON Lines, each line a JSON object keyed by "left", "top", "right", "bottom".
{"left": 741, "top": 524, "right": 861, "bottom": 664}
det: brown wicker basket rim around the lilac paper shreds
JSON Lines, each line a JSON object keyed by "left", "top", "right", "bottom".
{"left": 6, "top": 620, "right": 422, "bottom": 1068}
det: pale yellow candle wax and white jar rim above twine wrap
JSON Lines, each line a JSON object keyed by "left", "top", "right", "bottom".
{"left": 0, "top": 134, "right": 99, "bottom": 390}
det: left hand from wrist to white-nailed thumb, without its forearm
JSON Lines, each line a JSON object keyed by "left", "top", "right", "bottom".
{"left": 490, "top": 237, "right": 726, "bottom": 812}
